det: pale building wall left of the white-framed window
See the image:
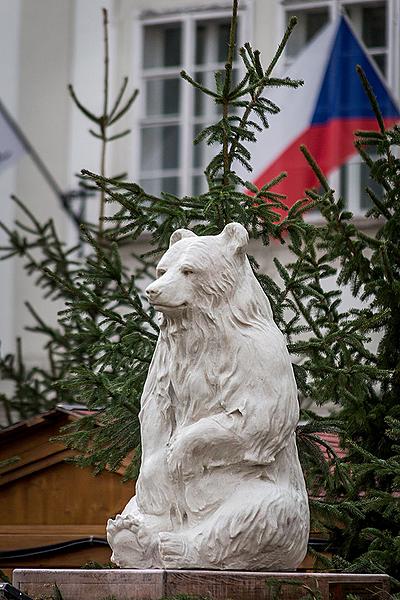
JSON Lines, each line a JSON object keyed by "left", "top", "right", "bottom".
{"left": 0, "top": 0, "right": 119, "bottom": 363}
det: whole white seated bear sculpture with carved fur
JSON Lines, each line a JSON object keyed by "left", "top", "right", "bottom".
{"left": 107, "top": 223, "right": 309, "bottom": 570}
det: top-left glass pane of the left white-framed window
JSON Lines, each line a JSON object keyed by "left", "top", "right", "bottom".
{"left": 143, "top": 23, "right": 182, "bottom": 69}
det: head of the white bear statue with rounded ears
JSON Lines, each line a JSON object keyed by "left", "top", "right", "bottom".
{"left": 146, "top": 223, "right": 249, "bottom": 314}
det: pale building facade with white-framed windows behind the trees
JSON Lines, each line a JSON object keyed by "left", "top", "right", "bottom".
{"left": 0, "top": 0, "right": 400, "bottom": 370}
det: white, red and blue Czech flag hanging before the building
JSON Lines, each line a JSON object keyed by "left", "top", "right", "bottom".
{"left": 252, "top": 16, "right": 400, "bottom": 206}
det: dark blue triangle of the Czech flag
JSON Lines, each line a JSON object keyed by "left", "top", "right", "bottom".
{"left": 312, "top": 16, "right": 400, "bottom": 124}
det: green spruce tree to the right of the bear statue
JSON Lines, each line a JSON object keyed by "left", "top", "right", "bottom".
{"left": 262, "top": 68, "right": 400, "bottom": 588}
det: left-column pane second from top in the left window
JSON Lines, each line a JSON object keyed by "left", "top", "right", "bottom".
{"left": 146, "top": 79, "right": 181, "bottom": 116}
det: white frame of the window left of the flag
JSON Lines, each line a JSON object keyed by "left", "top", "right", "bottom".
{"left": 131, "top": 2, "right": 252, "bottom": 195}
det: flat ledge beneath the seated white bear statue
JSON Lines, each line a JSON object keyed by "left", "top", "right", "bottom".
{"left": 13, "top": 569, "right": 389, "bottom": 600}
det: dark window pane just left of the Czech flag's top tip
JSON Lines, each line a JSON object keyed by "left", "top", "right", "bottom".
{"left": 286, "top": 8, "right": 329, "bottom": 57}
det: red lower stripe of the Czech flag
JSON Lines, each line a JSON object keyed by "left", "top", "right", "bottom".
{"left": 254, "top": 118, "right": 398, "bottom": 212}
